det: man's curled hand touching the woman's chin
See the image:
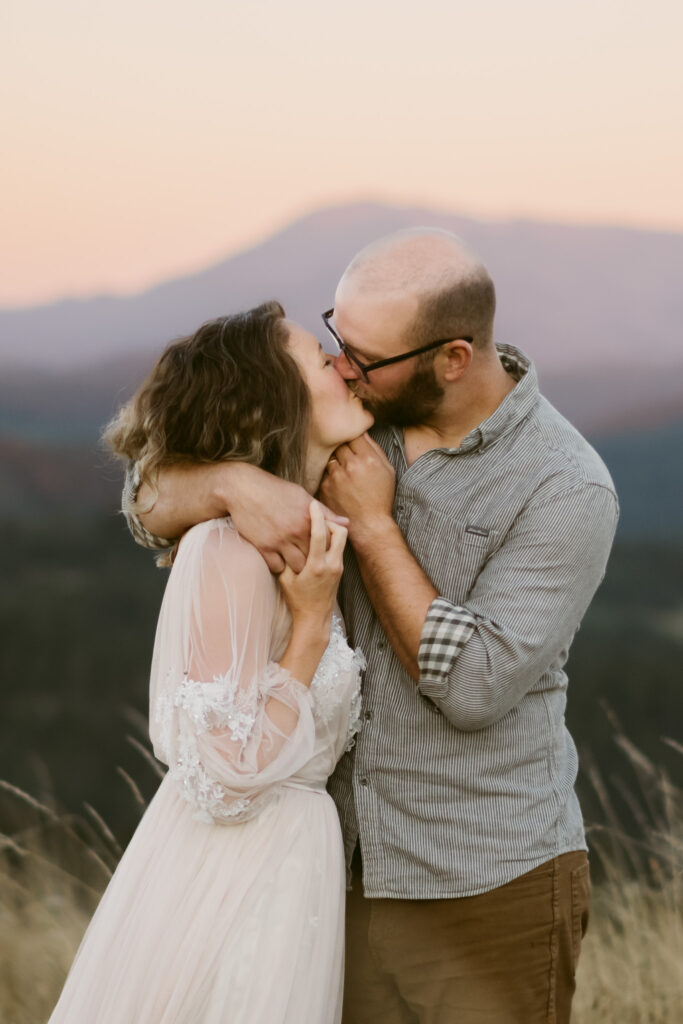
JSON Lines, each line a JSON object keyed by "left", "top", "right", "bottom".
{"left": 319, "top": 434, "right": 396, "bottom": 545}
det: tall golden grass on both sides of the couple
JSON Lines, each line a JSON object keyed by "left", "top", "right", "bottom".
{"left": 0, "top": 737, "right": 683, "bottom": 1024}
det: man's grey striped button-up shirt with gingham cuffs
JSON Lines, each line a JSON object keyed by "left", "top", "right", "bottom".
{"left": 124, "top": 345, "right": 617, "bottom": 899}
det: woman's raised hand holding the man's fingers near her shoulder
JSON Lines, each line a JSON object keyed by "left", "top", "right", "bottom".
{"left": 280, "top": 501, "right": 347, "bottom": 634}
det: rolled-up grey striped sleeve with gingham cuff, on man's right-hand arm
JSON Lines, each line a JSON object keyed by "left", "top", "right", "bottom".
{"left": 418, "top": 483, "right": 618, "bottom": 731}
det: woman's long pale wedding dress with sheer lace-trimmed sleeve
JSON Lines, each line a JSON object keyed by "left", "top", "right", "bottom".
{"left": 49, "top": 519, "right": 361, "bottom": 1024}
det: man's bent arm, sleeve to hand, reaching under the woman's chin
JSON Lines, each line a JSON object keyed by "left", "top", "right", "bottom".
{"left": 323, "top": 442, "right": 617, "bottom": 730}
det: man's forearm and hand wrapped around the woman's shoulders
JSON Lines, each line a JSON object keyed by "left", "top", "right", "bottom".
{"left": 123, "top": 462, "right": 347, "bottom": 572}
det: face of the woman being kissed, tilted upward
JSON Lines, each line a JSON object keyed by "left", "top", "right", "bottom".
{"left": 287, "top": 321, "right": 373, "bottom": 449}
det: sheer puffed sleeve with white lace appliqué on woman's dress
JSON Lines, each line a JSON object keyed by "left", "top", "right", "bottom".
{"left": 151, "top": 519, "right": 315, "bottom": 823}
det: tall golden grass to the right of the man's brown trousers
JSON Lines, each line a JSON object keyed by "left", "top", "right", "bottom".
{"left": 572, "top": 735, "right": 683, "bottom": 1024}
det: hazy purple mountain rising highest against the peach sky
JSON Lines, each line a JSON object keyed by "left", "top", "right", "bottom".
{"left": 0, "top": 203, "right": 683, "bottom": 391}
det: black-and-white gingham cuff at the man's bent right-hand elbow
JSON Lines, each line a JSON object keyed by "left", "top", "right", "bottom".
{"left": 418, "top": 597, "right": 476, "bottom": 697}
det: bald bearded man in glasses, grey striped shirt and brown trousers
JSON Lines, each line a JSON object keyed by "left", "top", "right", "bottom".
{"left": 124, "top": 231, "right": 617, "bottom": 1024}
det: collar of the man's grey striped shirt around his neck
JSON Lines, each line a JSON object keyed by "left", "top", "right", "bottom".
{"left": 391, "top": 345, "right": 539, "bottom": 455}
